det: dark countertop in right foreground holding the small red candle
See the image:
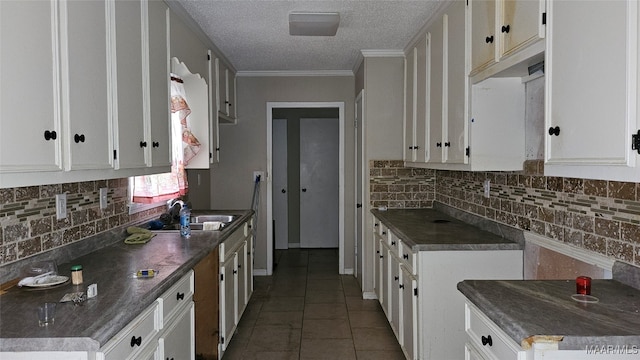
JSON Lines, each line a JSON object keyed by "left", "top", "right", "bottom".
{"left": 458, "top": 279, "right": 640, "bottom": 350}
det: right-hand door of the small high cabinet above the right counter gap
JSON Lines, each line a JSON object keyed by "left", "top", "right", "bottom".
{"left": 498, "top": 0, "right": 544, "bottom": 57}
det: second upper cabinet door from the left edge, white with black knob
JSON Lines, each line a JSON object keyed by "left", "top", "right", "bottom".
{"left": 60, "top": 1, "right": 113, "bottom": 170}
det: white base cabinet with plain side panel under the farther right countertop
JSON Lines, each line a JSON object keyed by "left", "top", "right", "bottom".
{"left": 369, "top": 216, "right": 523, "bottom": 360}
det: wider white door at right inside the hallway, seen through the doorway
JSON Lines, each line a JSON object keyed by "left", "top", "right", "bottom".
{"left": 300, "top": 118, "right": 340, "bottom": 248}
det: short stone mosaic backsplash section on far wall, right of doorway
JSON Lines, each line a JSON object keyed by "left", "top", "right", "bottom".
{"left": 369, "top": 160, "right": 436, "bottom": 209}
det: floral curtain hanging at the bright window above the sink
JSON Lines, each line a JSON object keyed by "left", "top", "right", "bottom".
{"left": 133, "top": 74, "right": 201, "bottom": 204}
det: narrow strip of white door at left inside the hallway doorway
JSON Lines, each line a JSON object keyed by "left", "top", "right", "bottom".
{"left": 271, "top": 119, "right": 289, "bottom": 249}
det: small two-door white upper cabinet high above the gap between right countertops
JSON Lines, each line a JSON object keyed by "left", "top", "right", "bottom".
{"left": 467, "top": 0, "right": 545, "bottom": 83}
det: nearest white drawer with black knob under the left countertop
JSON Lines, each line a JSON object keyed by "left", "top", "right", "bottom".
{"left": 102, "top": 301, "right": 162, "bottom": 360}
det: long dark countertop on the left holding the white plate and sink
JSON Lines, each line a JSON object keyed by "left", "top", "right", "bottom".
{"left": 0, "top": 210, "right": 253, "bottom": 351}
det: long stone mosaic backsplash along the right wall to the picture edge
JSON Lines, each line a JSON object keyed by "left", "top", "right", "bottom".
{"left": 435, "top": 160, "right": 640, "bottom": 265}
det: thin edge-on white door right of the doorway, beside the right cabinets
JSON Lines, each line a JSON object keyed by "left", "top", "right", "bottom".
{"left": 353, "top": 90, "right": 364, "bottom": 286}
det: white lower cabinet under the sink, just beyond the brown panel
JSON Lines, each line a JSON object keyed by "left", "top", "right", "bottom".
{"left": 218, "top": 220, "right": 253, "bottom": 357}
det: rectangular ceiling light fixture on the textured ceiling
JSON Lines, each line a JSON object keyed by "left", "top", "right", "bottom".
{"left": 289, "top": 12, "right": 340, "bottom": 36}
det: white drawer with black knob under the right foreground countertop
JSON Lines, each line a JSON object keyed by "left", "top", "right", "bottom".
{"left": 465, "top": 302, "right": 526, "bottom": 360}
